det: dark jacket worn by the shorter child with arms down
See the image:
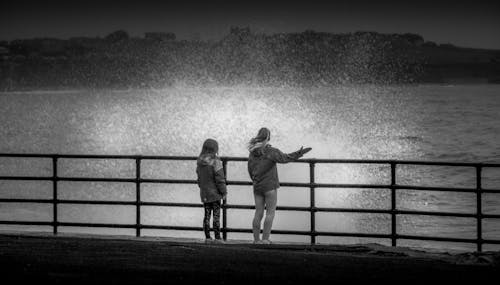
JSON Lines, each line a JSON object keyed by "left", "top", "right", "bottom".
{"left": 196, "top": 154, "right": 227, "bottom": 203}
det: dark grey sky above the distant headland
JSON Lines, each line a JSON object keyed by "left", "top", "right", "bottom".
{"left": 0, "top": 0, "right": 500, "bottom": 49}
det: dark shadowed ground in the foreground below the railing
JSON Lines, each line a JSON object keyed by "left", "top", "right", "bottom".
{"left": 0, "top": 233, "right": 500, "bottom": 285}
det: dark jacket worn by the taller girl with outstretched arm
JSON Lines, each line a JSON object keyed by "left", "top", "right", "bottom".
{"left": 248, "top": 144, "right": 303, "bottom": 194}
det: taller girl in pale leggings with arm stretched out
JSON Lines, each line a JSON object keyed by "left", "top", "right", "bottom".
{"left": 248, "top": 128, "right": 311, "bottom": 244}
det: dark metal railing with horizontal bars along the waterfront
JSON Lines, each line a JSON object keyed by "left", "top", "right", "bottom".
{"left": 0, "top": 153, "right": 500, "bottom": 251}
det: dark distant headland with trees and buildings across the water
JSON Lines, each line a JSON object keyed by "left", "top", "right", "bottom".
{"left": 0, "top": 27, "right": 500, "bottom": 90}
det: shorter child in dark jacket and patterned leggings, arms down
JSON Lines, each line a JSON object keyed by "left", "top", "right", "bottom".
{"left": 196, "top": 139, "right": 227, "bottom": 242}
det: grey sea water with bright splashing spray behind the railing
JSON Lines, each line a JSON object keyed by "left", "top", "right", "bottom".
{"left": 0, "top": 85, "right": 500, "bottom": 250}
